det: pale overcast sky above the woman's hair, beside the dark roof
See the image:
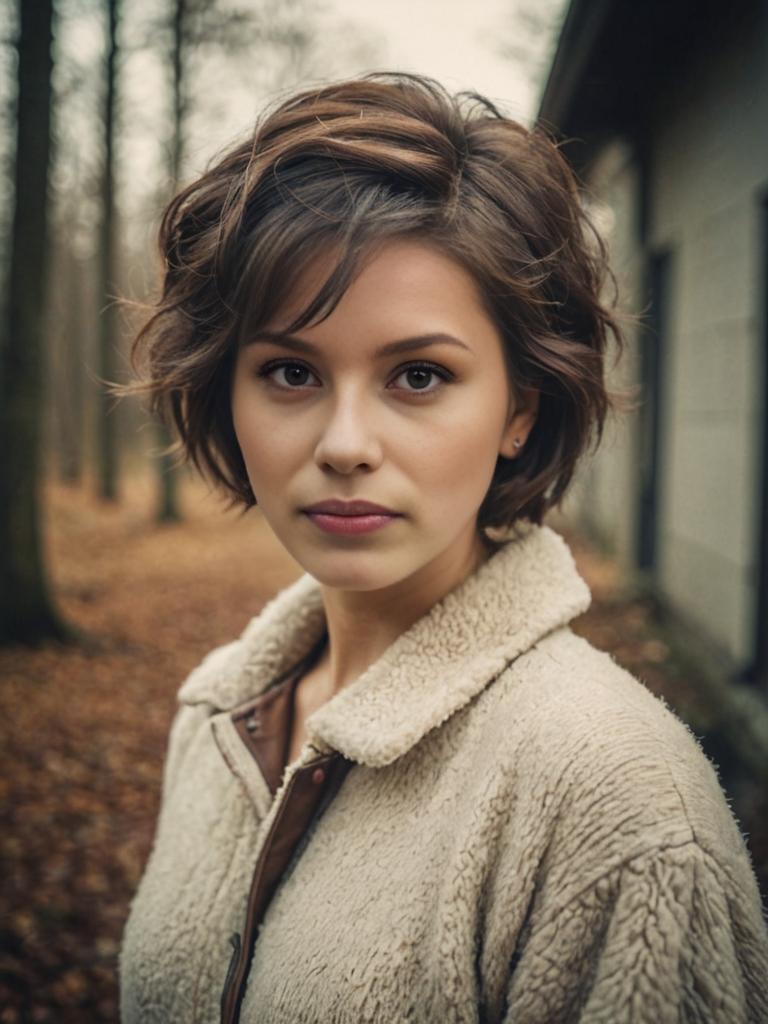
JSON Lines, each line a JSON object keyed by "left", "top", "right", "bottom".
{"left": 174, "top": 0, "right": 563, "bottom": 174}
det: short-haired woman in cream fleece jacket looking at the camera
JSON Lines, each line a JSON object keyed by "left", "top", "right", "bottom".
{"left": 121, "top": 75, "right": 768, "bottom": 1024}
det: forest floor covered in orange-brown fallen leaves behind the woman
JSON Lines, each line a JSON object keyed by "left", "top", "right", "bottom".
{"left": 0, "top": 480, "right": 768, "bottom": 1024}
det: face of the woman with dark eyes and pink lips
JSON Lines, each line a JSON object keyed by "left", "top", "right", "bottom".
{"left": 232, "top": 241, "right": 536, "bottom": 591}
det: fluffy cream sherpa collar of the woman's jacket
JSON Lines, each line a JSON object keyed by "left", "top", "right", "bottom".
{"left": 179, "top": 524, "right": 590, "bottom": 767}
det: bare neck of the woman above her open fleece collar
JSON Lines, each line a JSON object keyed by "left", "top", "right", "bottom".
{"left": 314, "top": 531, "right": 495, "bottom": 696}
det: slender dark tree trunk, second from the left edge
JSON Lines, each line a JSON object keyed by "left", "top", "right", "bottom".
{"left": 97, "top": 0, "right": 120, "bottom": 501}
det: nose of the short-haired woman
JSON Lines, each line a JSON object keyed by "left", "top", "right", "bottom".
{"left": 314, "top": 392, "right": 383, "bottom": 475}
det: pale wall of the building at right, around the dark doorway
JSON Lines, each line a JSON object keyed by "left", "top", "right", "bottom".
{"left": 571, "top": 12, "right": 768, "bottom": 665}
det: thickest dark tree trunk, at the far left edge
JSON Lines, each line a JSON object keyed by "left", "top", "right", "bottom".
{"left": 0, "top": 0, "right": 70, "bottom": 644}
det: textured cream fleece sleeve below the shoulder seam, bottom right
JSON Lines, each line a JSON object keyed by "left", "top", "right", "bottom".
{"left": 504, "top": 842, "right": 768, "bottom": 1024}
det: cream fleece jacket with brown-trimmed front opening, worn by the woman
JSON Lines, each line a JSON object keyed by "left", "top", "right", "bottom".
{"left": 120, "top": 526, "right": 768, "bottom": 1024}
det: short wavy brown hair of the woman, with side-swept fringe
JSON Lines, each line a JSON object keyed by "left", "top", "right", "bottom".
{"left": 132, "top": 73, "right": 622, "bottom": 530}
